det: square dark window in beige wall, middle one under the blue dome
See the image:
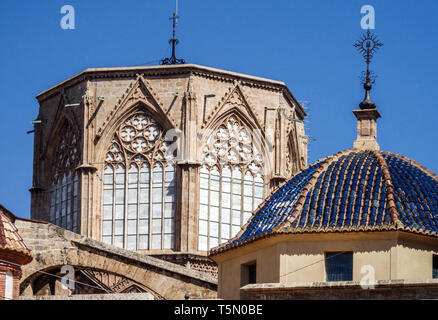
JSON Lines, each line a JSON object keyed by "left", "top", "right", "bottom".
{"left": 325, "top": 252, "right": 353, "bottom": 281}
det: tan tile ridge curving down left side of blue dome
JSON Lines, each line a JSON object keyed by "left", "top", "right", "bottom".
{"left": 271, "top": 149, "right": 353, "bottom": 233}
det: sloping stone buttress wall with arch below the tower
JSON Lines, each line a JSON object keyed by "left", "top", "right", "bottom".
{"left": 15, "top": 219, "right": 217, "bottom": 299}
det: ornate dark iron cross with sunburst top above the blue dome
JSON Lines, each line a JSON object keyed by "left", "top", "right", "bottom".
{"left": 354, "top": 29, "right": 383, "bottom": 109}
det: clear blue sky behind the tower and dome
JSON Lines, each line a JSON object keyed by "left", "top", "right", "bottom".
{"left": 0, "top": 0, "right": 438, "bottom": 217}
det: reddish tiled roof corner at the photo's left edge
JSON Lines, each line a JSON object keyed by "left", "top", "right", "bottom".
{"left": 0, "top": 206, "right": 32, "bottom": 261}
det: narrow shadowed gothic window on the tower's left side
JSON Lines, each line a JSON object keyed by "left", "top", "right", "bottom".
{"left": 49, "top": 121, "right": 80, "bottom": 232}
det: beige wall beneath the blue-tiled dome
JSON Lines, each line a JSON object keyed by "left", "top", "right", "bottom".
{"left": 212, "top": 232, "right": 438, "bottom": 299}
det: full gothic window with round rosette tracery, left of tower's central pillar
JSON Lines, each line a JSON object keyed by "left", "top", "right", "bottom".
{"left": 102, "top": 112, "right": 175, "bottom": 250}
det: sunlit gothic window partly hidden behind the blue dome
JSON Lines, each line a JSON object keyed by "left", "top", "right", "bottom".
{"left": 198, "top": 115, "right": 264, "bottom": 251}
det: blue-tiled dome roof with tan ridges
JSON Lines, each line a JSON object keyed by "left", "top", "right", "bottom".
{"left": 211, "top": 149, "right": 438, "bottom": 254}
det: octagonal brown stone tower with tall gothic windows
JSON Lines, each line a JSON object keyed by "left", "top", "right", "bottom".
{"left": 31, "top": 64, "right": 307, "bottom": 259}
